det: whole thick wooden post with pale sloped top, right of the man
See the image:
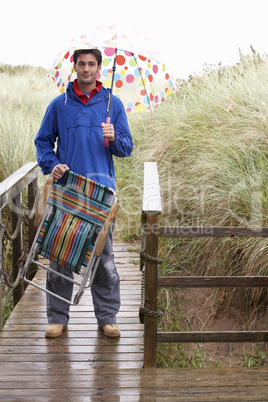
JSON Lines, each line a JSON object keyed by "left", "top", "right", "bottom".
{"left": 142, "top": 162, "right": 161, "bottom": 368}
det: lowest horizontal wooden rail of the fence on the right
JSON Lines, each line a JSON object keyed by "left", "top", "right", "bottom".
{"left": 157, "top": 331, "right": 268, "bottom": 343}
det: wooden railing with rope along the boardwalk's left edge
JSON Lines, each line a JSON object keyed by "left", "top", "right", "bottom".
{"left": 0, "top": 162, "right": 40, "bottom": 329}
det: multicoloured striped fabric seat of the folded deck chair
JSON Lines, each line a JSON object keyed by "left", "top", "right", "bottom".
{"left": 37, "top": 171, "right": 112, "bottom": 273}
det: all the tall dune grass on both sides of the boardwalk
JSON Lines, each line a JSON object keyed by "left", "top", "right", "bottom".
{"left": 0, "top": 49, "right": 268, "bottom": 367}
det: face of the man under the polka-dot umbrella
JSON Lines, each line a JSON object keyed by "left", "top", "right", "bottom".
{"left": 74, "top": 53, "right": 101, "bottom": 85}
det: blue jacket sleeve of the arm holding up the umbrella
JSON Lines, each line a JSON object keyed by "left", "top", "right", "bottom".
{"left": 109, "top": 97, "right": 133, "bottom": 157}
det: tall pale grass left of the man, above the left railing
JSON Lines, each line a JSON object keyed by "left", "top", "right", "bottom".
{"left": 0, "top": 65, "right": 58, "bottom": 181}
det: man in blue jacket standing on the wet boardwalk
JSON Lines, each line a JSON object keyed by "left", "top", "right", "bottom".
{"left": 35, "top": 49, "right": 133, "bottom": 338}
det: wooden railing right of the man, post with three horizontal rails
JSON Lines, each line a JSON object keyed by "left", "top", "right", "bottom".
{"left": 142, "top": 162, "right": 268, "bottom": 368}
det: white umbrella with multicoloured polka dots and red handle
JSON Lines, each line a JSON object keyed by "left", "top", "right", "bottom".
{"left": 49, "top": 25, "right": 176, "bottom": 144}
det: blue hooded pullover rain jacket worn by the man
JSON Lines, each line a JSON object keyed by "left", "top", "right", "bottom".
{"left": 35, "top": 82, "right": 133, "bottom": 189}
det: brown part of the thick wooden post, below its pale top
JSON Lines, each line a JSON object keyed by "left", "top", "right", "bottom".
{"left": 144, "top": 215, "right": 158, "bottom": 368}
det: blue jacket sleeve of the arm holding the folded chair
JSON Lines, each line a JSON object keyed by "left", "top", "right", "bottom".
{"left": 34, "top": 101, "right": 60, "bottom": 174}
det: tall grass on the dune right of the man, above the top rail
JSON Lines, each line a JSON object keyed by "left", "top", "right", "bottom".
{"left": 120, "top": 53, "right": 268, "bottom": 269}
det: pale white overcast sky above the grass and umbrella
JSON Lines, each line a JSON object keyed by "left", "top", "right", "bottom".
{"left": 0, "top": 0, "right": 268, "bottom": 79}
